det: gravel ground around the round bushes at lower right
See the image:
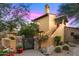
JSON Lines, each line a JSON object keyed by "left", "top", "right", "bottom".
{"left": 51, "top": 45, "right": 79, "bottom": 56}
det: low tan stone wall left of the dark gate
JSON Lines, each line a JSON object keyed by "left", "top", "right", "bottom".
{"left": 0, "top": 32, "right": 22, "bottom": 52}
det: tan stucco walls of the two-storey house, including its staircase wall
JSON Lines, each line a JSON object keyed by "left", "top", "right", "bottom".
{"left": 36, "top": 14, "right": 64, "bottom": 47}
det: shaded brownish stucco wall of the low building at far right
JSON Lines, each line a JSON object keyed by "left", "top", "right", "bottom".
{"left": 64, "top": 27, "right": 79, "bottom": 42}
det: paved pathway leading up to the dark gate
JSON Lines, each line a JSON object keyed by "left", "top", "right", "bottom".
{"left": 17, "top": 50, "right": 44, "bottom": 56}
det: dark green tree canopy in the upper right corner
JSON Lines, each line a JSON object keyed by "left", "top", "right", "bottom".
{"left": 59, "top": 3, "right": 79, "bottom": 20}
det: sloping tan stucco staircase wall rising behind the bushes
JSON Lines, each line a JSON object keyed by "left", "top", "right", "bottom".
{"left": 41, "top": 24, "right": 64, "bottom": 47}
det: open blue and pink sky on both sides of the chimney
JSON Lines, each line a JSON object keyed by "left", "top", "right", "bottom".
{"left": 30, "top": 3, "right": 61, "bottom": 19}
